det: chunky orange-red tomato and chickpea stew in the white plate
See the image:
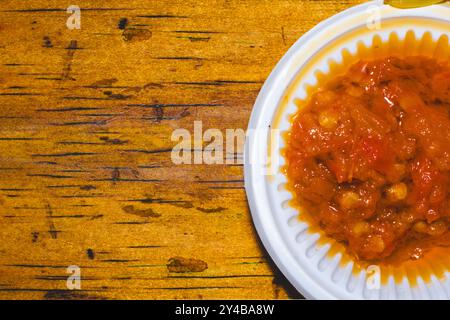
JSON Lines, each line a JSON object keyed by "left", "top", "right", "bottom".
{"left": 285, "top": 56, "right": 450, "bottom": 261}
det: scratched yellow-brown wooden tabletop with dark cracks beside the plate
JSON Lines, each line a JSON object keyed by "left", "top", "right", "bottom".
{"left": 0, "top": 0, "right": 361, "bottom": 299}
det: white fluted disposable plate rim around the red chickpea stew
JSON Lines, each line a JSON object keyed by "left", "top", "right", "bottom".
{"left": 244, "top": 2, "right": 450, "bottom": 299}
